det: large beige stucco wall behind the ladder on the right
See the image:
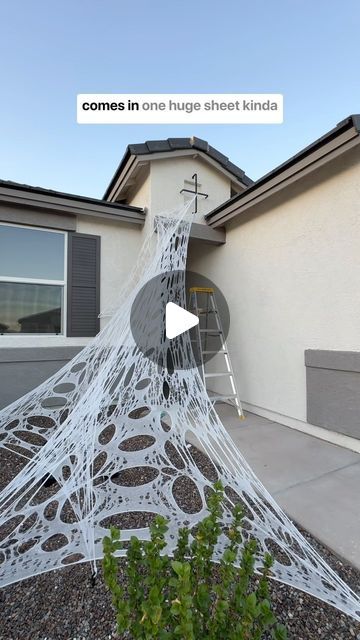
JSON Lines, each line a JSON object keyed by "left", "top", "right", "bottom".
{"left": 189, "top": 150, "right": 360, "bottom": 422}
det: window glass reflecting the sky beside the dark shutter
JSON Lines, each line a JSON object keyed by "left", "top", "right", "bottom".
{"left": 0, "top": 224, "right": 66, "bottom": 334}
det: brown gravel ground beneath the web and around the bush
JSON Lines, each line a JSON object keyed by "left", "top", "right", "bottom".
{"left": 0, "top": 438, "right": 360, "bottom": 640}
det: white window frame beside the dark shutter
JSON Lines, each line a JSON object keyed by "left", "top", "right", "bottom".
{"left": 0, "top": 222, "right": 68, "bottom": 338}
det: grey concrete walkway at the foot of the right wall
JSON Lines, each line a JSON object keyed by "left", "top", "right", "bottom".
{"left": 216, "top": 404, "right": 360, "bottom": 569}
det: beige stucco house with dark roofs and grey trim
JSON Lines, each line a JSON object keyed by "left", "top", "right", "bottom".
{"left": 0, "top": 116, "right": 360, "bottom": 448}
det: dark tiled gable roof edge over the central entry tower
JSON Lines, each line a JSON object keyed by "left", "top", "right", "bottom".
{"left": 103, "top": 136, "right": 253, "bottom": 200}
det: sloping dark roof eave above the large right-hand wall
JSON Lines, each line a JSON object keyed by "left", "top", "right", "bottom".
{"left": 205, "top": 114, "right": 360, "bottom": 226}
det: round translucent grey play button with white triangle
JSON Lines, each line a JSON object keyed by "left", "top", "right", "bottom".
{"left": 130, "top": 271, "right": 230, "bottom": 371}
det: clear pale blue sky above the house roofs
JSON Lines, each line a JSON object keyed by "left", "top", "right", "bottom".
{"left": 0, "top": 0, "right": 360, "bottom": 197}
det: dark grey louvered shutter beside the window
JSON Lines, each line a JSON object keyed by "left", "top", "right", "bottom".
{"left": 67, "top": 233, "right": 100, "bottom": 338}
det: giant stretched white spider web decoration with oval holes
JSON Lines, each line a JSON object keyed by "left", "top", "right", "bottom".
{"left": 0, "top": 203, "right": 360, "bottom": 620}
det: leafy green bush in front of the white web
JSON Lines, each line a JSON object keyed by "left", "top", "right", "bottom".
{"left": 103, "top": 482, "right": 287, "bottom": 640}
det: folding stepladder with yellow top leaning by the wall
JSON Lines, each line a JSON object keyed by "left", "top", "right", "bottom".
{"left": 188, "top": 287, "right": 244, "bottom": 419}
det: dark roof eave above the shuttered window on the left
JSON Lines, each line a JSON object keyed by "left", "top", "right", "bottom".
{"left": 0, "top": 180, "right": 145, "bottom": 224}
